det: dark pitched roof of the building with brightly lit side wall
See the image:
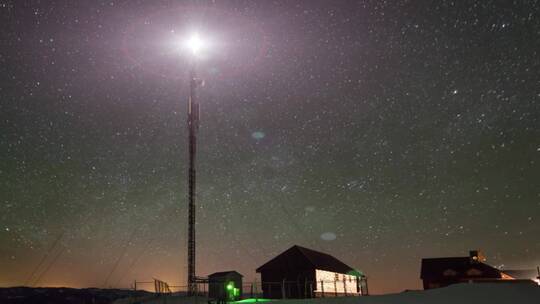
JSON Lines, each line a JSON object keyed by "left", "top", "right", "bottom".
{"left": 257, "top": 245, "right": 363, "bottom": 276}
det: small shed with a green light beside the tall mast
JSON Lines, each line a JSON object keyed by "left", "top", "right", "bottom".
{"left": 208, "top": 270, "right": 243, "bottom": 301}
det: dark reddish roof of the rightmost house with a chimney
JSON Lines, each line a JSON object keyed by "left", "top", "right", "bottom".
{"left": 420, "top": 257, "right": 501, "bottom": 280}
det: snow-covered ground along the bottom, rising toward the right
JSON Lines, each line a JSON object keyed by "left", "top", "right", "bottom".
{"left": 115, "top": 283, "right": 540, "bottom": 304}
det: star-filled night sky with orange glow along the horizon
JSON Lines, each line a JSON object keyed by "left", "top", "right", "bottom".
{"left": 0, "top": 0, "right": 540, "bottom": 293}
